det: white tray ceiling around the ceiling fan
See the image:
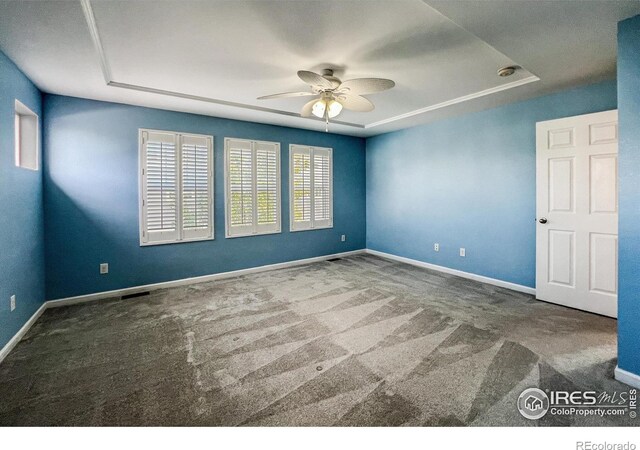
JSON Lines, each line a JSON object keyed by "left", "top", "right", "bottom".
{"left": 0, "top": 0, "right": 640, "bottom": 136}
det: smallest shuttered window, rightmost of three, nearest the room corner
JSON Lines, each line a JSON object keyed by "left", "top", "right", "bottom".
{"left": 289, "top": 145, "right": 333, "bottom": 231}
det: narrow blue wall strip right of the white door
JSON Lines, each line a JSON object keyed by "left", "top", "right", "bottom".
{"left": 618, "top": 16, "right": 640, "bottom": 375}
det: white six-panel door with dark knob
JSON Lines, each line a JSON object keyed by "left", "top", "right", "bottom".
{"left": 536, "top": 111, "right": 618, "bottom": 317}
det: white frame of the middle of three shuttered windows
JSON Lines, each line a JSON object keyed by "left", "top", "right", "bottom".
{"left": 224, "top": 138, "right": 282, "bottom": 239}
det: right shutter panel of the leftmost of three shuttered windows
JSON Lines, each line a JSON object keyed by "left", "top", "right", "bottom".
{"left": 180, "top": 135, "right": 213, "bottom": 239}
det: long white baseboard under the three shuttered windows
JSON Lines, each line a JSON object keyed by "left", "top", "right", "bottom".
{"left": 46, "top": 249, "right": 365, "bottom": 308}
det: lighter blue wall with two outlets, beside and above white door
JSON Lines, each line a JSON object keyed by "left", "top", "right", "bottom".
{"left": 366, "top": 81, "right": 616, "bottom": 287}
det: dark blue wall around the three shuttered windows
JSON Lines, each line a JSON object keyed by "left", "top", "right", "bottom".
{"left": 43, "top": 95, "right": 366, "bottom": 299}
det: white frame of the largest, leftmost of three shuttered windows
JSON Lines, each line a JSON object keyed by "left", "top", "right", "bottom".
{"left": 138, "top": 128, "right": 215, "bottom": 247}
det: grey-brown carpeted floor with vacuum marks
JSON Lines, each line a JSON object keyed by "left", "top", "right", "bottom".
{"left": 0, "top": 255, "right": 635, "bottom": 426}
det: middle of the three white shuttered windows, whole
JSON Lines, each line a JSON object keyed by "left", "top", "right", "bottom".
{"left": 224, "top": 138, "right": 280, "bottom": 238}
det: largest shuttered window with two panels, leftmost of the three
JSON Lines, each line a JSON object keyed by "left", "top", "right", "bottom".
{"left": 140, "top": 130, "right": 213, "bottom": 245}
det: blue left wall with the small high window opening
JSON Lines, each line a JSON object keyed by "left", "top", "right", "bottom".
{"left": 0, "top": 52, "right": 44, "bottom": 348}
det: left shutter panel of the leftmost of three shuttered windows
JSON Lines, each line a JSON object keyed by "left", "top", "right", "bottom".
{"left": 142, "top": 131, "right": 180, "bottom": 243}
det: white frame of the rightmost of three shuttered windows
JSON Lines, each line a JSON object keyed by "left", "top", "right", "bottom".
{"left": 289, "top": 144, "right": 333, "bottom": 232}
